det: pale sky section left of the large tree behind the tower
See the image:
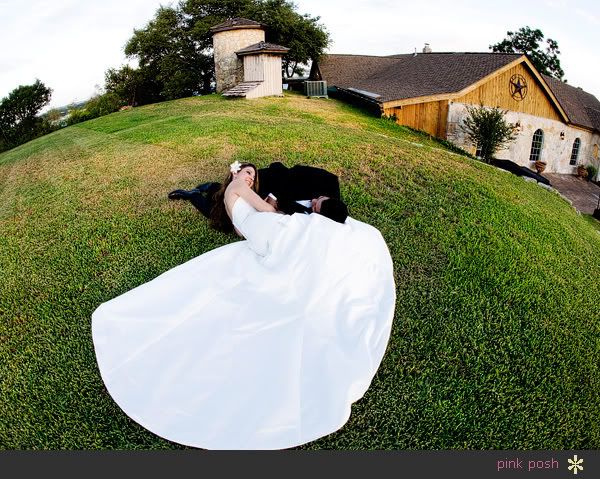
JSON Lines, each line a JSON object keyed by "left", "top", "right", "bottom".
{"left": 0, "top": 0, "right": 161, "bottom": 106}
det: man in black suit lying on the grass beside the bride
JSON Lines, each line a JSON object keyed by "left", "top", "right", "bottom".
{"left": 169, "top": 162, "right": 348, "bottom": 223}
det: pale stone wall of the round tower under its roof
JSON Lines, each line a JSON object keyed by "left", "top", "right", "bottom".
{"left": 213, "top": 28, "right": 265, "bottom": 93}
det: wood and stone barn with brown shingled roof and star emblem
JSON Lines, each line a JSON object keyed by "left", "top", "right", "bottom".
{"left": 310, "top": 49, "right": 600, "bottom": 173}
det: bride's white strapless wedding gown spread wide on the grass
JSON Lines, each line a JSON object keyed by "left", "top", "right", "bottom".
{"left": 92, "top": 198, "right": 395, "bottom": 449}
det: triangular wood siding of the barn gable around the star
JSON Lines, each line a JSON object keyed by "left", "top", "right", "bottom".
{"left": 453, "top": 63, "right": 562, "bottom": 121}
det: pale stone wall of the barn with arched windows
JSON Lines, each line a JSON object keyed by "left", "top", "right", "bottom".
{"left": 447, "top": 102, "right": 600, "bottom": 174}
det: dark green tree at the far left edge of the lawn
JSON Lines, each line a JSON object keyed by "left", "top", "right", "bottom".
{"left": 0, "top": 80, "right": 52, "bottom": 151}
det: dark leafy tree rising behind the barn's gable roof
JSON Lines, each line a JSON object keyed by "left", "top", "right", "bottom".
{"left": 490, "top": 27, "right": 566, "bottom": 81}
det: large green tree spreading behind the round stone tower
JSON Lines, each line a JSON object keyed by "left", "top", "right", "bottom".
{"left": 106, "top": 0, "right": 329, "bottom": 104}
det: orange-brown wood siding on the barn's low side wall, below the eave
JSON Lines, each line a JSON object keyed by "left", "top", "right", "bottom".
{"left": 384, "top": 100, "right": 448, "bottom": 138}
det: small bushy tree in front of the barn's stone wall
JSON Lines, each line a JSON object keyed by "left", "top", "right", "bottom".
{"left": 461, "top": 105, "right": 517, "bottom": 163}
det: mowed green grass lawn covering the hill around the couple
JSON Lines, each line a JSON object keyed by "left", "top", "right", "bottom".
{"left": 0, "top": 94, "right": 600, "bottom": 449}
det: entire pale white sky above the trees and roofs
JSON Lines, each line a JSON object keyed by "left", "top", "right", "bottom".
{"left": 0, "top": 0, "right": 600, "bottom": 110}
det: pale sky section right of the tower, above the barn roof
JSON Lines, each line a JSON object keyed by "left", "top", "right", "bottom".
{"left": 295, "top": 0, "right": 600, "bottom": 96}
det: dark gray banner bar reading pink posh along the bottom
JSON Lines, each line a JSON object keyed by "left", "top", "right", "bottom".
{"left": 0, "top": 450, "right": 600, "bottom": 479}
